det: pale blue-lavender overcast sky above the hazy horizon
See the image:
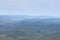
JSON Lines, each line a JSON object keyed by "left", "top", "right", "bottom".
{"left": 0, "top": 0, "right": 60, "bottom": 16}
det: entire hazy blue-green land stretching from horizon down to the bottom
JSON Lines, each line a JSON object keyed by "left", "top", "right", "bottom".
{"left": 0, "top": 15, "right": 60, "bottom": 40}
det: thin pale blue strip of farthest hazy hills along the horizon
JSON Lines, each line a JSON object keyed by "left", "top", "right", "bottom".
{"left": 0, "top": 15, "right": 58, "bottom": 20}
